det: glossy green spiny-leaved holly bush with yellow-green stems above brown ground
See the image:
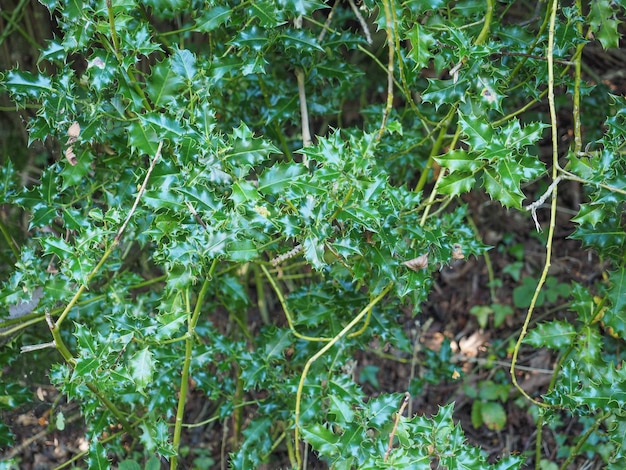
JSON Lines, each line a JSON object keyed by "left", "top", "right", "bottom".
{"left": 0, "top": 0, "right": 626, "bottom": 469}
